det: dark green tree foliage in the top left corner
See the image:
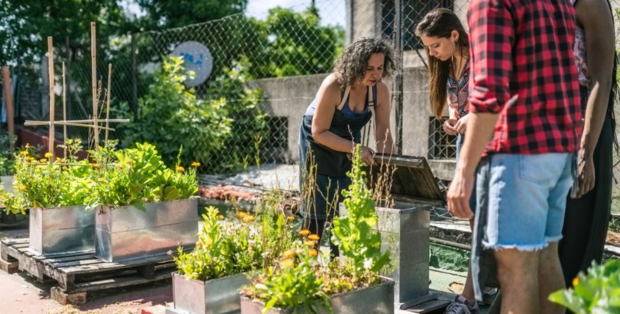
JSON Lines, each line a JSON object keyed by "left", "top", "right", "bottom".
{"left": 0, "top": 0, "right": 127, "bottom": 65}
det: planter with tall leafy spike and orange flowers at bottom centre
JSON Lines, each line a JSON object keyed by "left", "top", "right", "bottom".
{"left": 241, "top": 149, "right": 394, "bottom": 314}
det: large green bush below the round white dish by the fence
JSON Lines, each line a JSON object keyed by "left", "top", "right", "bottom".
{"left": 121, "top": 57, "right": 231, "bottom": 169}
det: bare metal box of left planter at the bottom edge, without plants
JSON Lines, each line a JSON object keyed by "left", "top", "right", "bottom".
{"left": 167, "top": 273, "right": 250, "bottom": 314}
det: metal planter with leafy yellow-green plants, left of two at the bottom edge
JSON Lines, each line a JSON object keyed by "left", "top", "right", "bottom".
{"left": 171, "top": 193, "right": 294, "bottom": 314}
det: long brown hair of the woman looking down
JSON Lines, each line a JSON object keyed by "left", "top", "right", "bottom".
{"left": 415, "top": 8, "right": 469, "bottom": 118}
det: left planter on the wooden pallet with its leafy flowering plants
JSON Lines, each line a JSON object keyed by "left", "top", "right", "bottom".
{"left": 0, "top": 140, "right": 95, "bottom": 255}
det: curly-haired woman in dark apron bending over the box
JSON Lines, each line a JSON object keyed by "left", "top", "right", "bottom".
{"left": 299, "top": 38, "right": 395, "bottom": 254}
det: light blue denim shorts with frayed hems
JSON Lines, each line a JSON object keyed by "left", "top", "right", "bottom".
{"left": 476, "top": 153, "right": 575, "bottom": 251}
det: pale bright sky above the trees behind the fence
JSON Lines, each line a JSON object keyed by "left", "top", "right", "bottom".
{"left": 121, "top": 0, "right": 346, "bottom": 27}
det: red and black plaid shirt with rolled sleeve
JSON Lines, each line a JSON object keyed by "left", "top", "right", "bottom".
{"left": 467, "top": 0, "right": 581, "bottom": 155}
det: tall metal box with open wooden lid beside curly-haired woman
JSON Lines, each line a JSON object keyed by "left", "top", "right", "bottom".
{"left": 364, "top": 155, "right": 445, "bottom": 309}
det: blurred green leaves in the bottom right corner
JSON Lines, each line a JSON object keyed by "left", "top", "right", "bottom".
{"left": 549, "top": 260, "right": 620, "bottom": 314}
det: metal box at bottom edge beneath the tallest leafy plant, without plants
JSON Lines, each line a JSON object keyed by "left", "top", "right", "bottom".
{"left": 241, "top": 280, "right": 394, "bottom": 314}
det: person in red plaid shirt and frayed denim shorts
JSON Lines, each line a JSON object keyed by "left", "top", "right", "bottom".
{"left": 448, "top": 0, "right": 581, "bottom": 314}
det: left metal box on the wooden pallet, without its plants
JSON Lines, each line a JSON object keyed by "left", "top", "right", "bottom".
{"left": 29, "top": 205, "right": 95, "bottom": 256}
